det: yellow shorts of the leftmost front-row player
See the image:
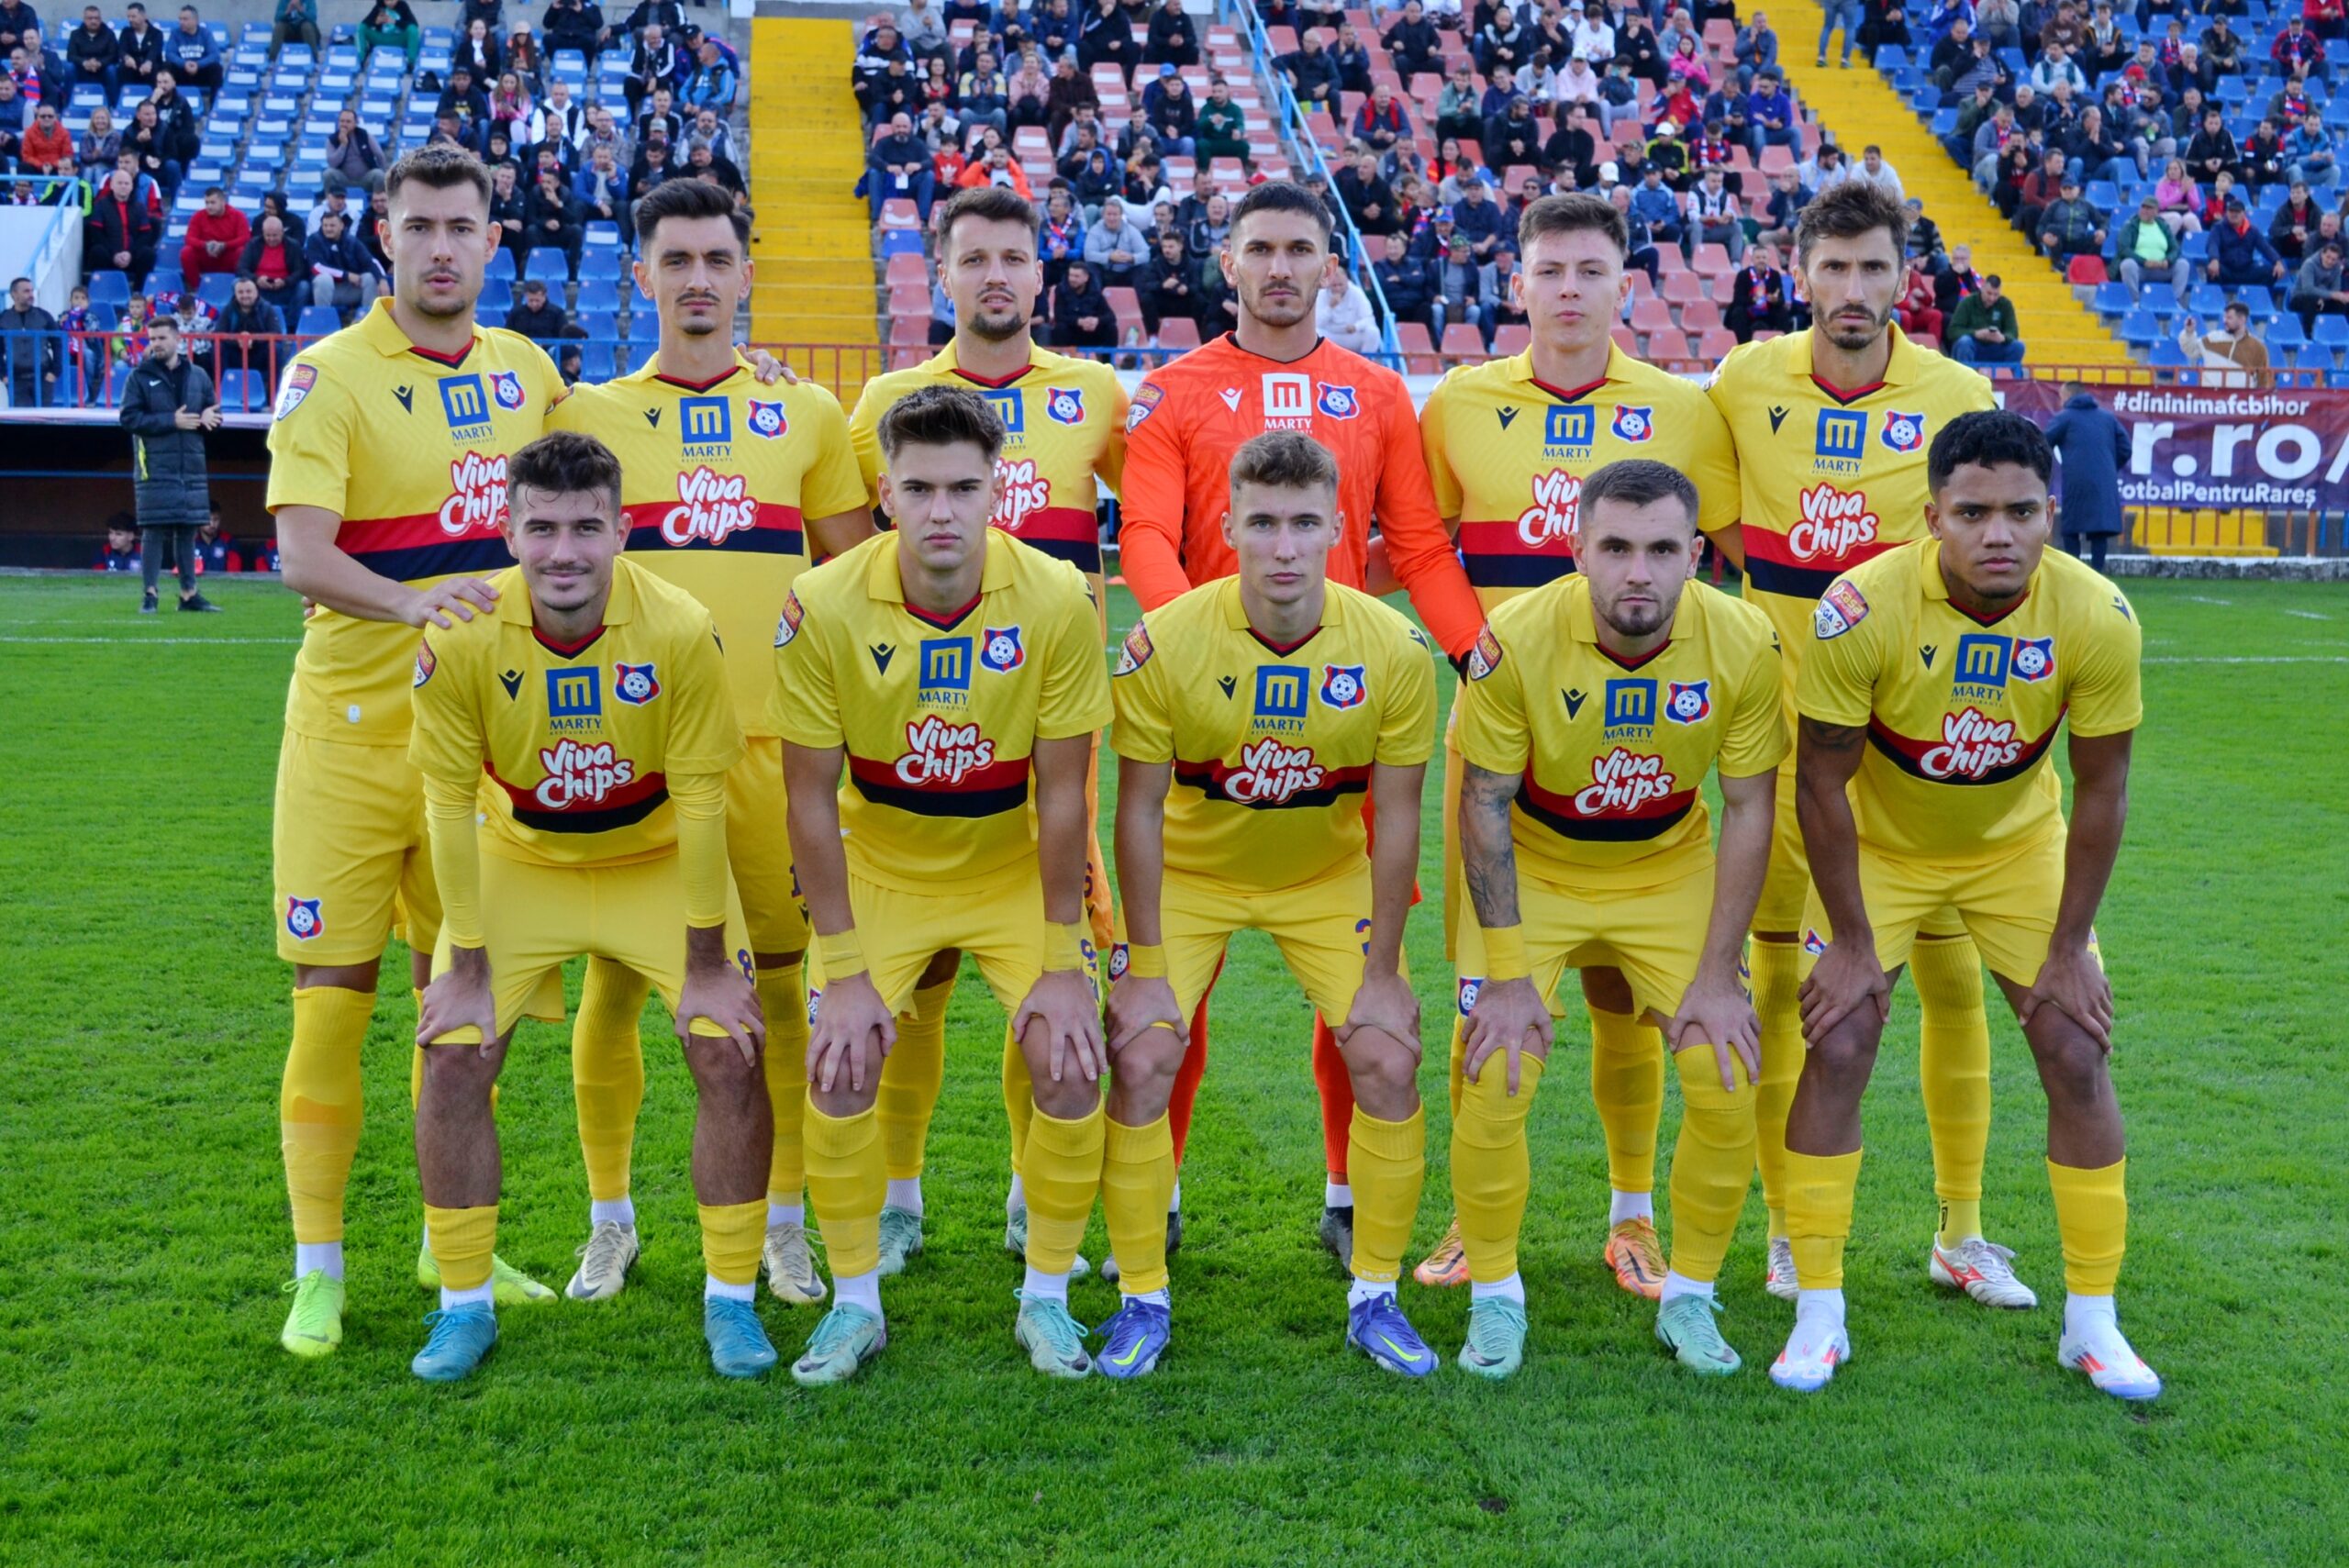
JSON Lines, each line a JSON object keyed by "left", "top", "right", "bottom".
{"left": 432, "top": 852, "right": 754, "bottom": 1042}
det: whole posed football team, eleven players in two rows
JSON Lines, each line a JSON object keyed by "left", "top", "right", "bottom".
{"left": 268, "top": 148, "right": 2161, "bottom": 1399}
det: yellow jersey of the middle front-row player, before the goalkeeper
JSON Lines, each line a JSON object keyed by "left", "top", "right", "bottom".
{"left": 1111, "top": 577, "right": 1435, "bottom": 892}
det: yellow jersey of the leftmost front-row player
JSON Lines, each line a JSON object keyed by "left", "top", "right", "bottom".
{"left": 408, "top": 556, "right": 742, "bottom": 866}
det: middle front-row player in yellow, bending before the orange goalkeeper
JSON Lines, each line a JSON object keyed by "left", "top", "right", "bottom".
{"left": 1099, "top": 429, "right": 1435, "bottom": 1378}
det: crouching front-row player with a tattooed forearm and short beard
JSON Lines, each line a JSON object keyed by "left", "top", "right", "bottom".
{"left": 1452, "top": 458, "right": 1787, "bottom": 1378}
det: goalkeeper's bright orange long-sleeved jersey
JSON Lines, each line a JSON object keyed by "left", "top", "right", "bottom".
{"left": 1119, "top": 333, "right": 1485, "bottom": 655}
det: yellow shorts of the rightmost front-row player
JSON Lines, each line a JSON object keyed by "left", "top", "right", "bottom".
{"left": 1802, "top": 833, "right": 2102, "bottom": 986}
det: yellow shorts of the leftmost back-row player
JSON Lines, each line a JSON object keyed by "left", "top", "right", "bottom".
{"left": 270, "top": 730, "right": 440, "bottom": 967}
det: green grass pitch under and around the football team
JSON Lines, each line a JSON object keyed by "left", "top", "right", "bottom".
{"left": 0, "top": 580, "right": 2349, "bottom": 1565}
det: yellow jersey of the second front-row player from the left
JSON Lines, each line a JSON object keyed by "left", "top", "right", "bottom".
{"left": 771, "top": 528, "right": 1108, "bottom": 895}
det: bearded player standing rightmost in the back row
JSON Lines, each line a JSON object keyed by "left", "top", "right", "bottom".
{"left": 1712, "top": 181, "right": 2037, "bottom": 1307}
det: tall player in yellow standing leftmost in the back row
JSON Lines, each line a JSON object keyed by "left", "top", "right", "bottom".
{"left": 268, "top": 148, "right": 563, "bottom": 1357}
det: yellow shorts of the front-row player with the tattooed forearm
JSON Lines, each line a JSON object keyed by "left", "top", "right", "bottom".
{"left": 1454, "top": 854, "right": 1712, "bottom": 1018}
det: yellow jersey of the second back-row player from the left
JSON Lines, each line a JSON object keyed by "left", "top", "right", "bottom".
{"left": 547, "top": 357, "right": 864, "bottom": 735}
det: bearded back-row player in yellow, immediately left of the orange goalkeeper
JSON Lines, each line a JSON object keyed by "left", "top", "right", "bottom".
{"left": 848, "top": 185, "right": 1125, "bottom": 1274}
